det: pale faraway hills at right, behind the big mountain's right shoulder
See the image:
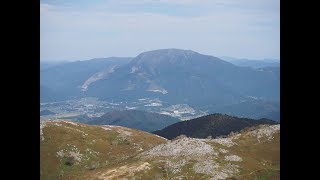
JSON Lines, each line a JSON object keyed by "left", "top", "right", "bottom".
{"left": 221, "top": 56, "right": 280, "bottom": 68}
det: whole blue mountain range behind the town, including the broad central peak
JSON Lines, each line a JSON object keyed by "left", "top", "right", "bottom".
{"left": 40, "top": 49, "right": 280, "bottom": 120}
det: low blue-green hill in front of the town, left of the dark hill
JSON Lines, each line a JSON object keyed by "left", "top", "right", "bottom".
{"left": 88, "top": 110, "right": 180, "bottom": 132}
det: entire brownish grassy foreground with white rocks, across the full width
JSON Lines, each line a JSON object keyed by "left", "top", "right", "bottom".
{"left": 40, "top": 121, "right": 280, "bottom": 179}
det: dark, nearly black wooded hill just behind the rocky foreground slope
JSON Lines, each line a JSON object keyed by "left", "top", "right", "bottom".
{"left": 153, "top": 114, "right": 277, "bottom": 139}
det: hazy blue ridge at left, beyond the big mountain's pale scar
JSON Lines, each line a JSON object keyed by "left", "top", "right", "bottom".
{"left": 40, "top": 57, "right": 131, "bottom": 102}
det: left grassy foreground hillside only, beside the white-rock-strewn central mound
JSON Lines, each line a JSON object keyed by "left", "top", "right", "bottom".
{"left": 40, "top": 121, "right": 166, "bottom": 179}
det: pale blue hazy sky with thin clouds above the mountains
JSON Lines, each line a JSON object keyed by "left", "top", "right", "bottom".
{"left": 40, "top": 0, "right": 280, "bottom": 61}
